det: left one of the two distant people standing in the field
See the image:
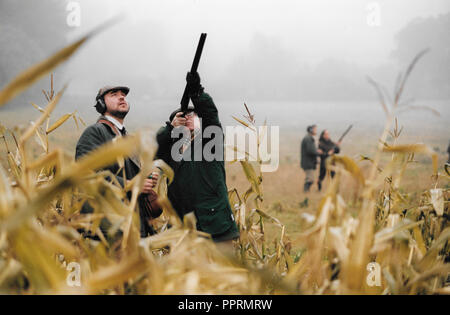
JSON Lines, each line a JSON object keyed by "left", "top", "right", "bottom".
{"left": 300, "top": 125, "right": 323, "bottom": 192}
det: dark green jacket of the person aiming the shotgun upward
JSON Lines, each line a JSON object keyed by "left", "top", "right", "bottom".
{"left": 157, "top": 93, "right": 237, "bottom": 238}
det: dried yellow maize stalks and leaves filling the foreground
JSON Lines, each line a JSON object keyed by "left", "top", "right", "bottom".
{"left": 0, "top": 27, "right": 450, "bottom": 294}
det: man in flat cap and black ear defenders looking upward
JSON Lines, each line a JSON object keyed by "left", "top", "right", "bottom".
{"left": 75, "top": 86, "right": 161, "bottom": 237}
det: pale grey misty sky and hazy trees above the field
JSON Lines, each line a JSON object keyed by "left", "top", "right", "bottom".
{"left": 0, "top": 0, "right": 450, "bottom": 150}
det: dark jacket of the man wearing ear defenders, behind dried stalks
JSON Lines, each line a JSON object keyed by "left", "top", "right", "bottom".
{"left": 75, "top": 116, "right": 154, "bottom": 237}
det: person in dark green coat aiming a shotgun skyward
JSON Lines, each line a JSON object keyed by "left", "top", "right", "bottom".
{"left": 157, "top": 73, "right": 239, "bottom": 242}
